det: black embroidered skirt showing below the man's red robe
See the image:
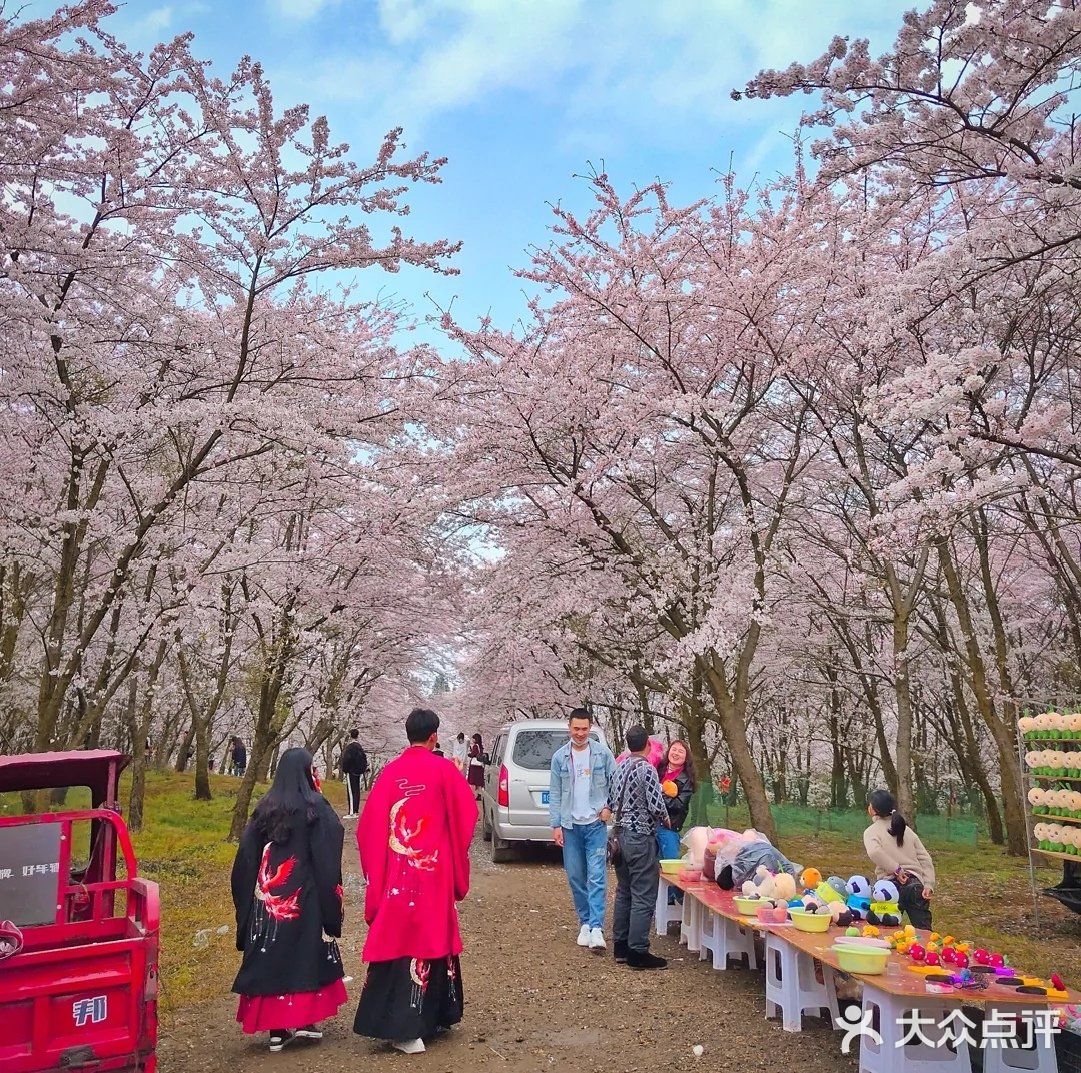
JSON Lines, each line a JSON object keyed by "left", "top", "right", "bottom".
{"left": 352, "top": 956, "right": 463, "bottom": 1043}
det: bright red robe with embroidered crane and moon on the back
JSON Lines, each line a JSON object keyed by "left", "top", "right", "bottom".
{"left": 357, "top": 746, "right": 477, "bottom": 962}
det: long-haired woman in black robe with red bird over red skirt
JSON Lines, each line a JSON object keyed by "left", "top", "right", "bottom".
{"left": 231, "top": 749, "right": 348, "bottom": 1051}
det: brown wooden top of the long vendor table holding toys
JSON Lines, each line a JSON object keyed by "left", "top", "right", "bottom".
{"left": 665, "top": 875, "right": 1081, "bottom": 1008}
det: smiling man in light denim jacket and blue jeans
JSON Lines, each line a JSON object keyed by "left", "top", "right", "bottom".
{"left": 548, "top": 708, "right": 615, "bottom": 954}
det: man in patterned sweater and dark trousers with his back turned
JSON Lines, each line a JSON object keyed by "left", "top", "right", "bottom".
{"left": 612, "top": 726, "right": 670, "bottom": 969}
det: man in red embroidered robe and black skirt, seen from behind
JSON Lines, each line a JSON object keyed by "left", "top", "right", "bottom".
{"left": 353, "top": 708, "right": 477, "bottom": 1055}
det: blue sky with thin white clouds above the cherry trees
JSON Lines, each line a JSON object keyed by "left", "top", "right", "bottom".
{"left": 103, "top": 0, "right": 911, "bottom": 334}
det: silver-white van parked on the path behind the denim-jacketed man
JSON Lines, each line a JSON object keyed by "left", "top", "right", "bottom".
{"left": 480, "top": 719, "right": 604, "bottom": 863}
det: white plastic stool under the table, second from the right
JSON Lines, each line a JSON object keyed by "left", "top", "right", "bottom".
{"left": 859, "top": 978, "right": 989, "bottom": 1073}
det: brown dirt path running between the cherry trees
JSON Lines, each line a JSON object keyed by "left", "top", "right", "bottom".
{"left": 160, "top": 824, "right": 856, "bottom": 1073}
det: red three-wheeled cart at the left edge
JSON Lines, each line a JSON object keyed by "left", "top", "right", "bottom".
{"left": 0, "top": 750, "right": 159, "bottom": 1073}
